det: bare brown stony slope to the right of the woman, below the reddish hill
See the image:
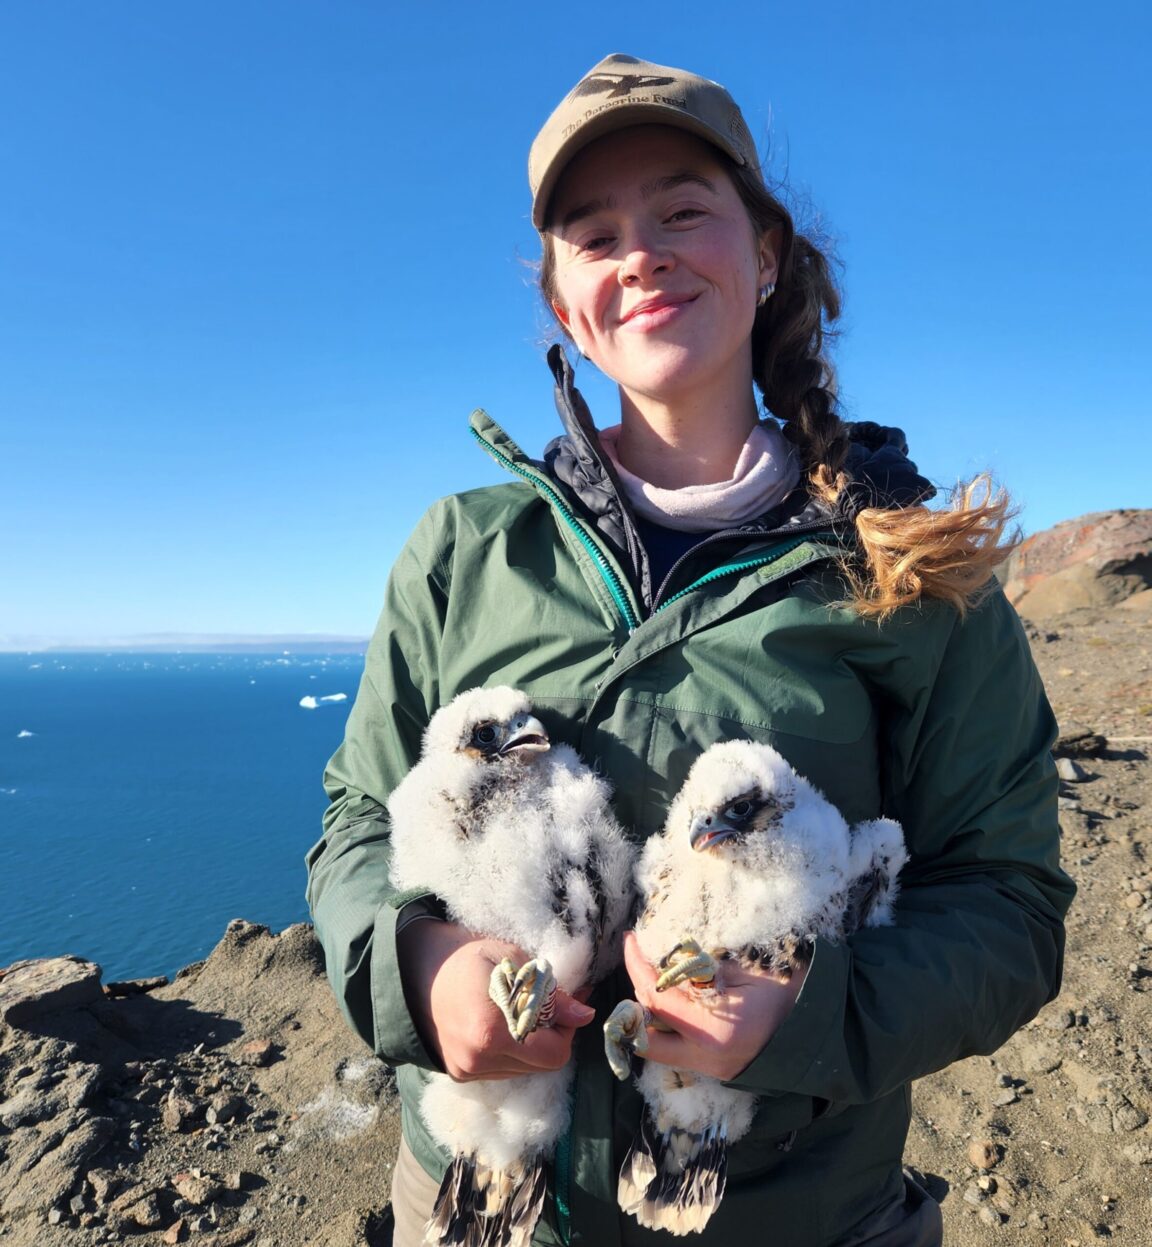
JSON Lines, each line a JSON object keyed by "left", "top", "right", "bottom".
{"left": 908, "top": 599, "right": 1152, "bottom": 1247}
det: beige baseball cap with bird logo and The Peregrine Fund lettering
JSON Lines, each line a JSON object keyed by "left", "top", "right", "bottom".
{"left": 529, "top": 52, "right": 761, "bottom": 229}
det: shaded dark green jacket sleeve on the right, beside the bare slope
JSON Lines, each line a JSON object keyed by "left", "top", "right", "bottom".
{"left": 729, "top": 592, "right": 1075, "bottom": 1102}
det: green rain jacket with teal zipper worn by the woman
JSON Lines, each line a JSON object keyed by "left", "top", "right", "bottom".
{"left": 309, "top": 354, "right": 1073, "bottom": 1247}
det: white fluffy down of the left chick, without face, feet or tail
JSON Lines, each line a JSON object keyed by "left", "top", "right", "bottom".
{"left": 388, "top": 687, "right": 635, "bottom": 1170}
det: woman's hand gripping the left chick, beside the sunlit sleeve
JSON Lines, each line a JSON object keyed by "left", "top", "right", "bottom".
{"left": 396, "top": 919, "right": 595, "bottom": 1082}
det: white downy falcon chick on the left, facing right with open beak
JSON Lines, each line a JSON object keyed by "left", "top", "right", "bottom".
{"left": 388, "top": 687, "right": 635, "bottom": 1247}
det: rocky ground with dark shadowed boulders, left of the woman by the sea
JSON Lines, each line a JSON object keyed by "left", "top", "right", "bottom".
{"left": 0, "top": 922, "right": 399, "bottom": 1247}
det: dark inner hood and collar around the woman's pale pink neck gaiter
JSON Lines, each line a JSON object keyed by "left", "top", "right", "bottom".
{"left": 544, "top": 345, "right": 936, "bottom": 536}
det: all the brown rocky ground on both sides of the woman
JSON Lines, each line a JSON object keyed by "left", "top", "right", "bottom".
{"left": 0, "top": 599, "right": 1152, "bottom": 1247}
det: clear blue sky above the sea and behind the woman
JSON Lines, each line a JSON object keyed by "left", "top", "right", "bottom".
{"left": 0, "top": 0, "right": 1152, "bottom": 637}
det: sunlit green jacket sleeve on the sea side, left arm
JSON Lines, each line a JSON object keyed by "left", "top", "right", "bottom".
{"left": 308, "top": 508, "right": 448, "bottom": 1069}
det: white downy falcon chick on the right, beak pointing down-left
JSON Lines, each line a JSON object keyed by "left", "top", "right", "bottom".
{"left": 605, "top": 741, "right": 906, "bottom": 1235}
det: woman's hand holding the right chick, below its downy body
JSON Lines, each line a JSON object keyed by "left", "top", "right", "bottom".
{"left": 625, "top": 932, "right": 807, "bottom": 1081}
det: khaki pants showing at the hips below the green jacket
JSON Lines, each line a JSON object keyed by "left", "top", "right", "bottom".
{"left": 391, "top": 1140, "right": 944, "bottom": 1247}
